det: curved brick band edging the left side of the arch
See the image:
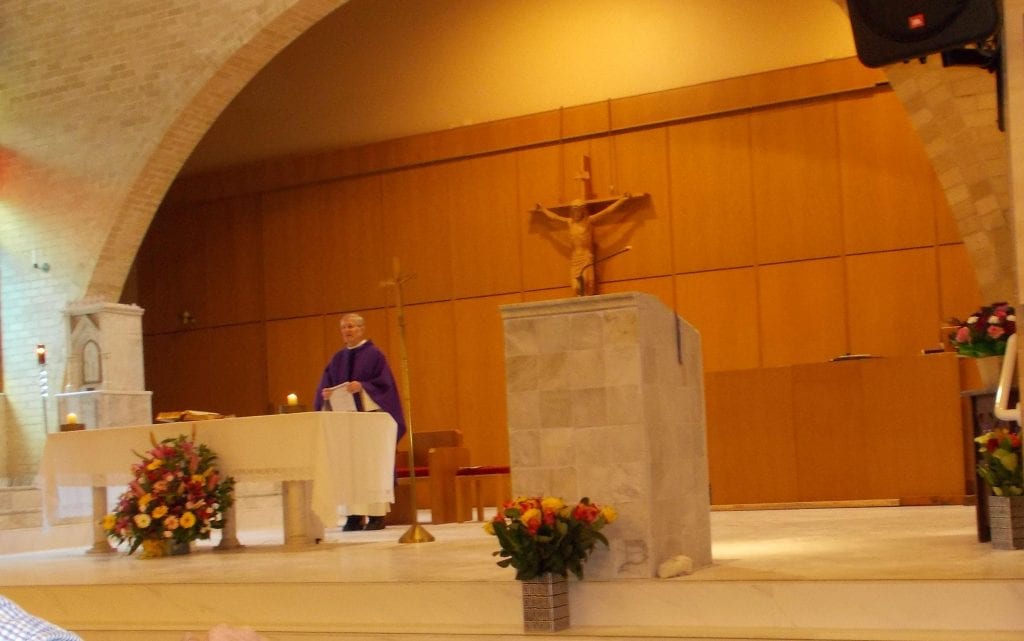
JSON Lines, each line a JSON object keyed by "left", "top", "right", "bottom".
{"left": 86, "top": 0, "right": 347, "bottom": 300}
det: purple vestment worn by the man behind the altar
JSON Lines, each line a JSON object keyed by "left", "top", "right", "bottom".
{"left": 313, "top": 340, "right": 406, "bottom": 439}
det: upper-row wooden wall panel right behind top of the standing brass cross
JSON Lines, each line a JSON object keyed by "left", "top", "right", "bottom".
{"left": 382, "top": 165, "right": 459, "bottom": 304}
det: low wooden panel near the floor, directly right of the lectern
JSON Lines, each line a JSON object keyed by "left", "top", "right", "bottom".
{"left": 705, "top": 368, "right": 804, "bottom": 505}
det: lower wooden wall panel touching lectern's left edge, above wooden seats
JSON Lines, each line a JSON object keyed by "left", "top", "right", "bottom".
{"left": 454, "top": 294, "right": 519, "bottom": 465}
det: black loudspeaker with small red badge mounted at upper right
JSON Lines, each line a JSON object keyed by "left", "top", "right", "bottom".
{"left": 847, "top": 0, "right": 999, "bottom": 67}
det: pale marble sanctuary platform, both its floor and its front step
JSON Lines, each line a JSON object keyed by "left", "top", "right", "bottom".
{"left": 0, "top": 506, "right": 1024, "bottom": 641}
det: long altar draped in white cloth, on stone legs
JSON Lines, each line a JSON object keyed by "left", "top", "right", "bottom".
{"left": 41, "top": 412, "right": 397, "bottom": 552}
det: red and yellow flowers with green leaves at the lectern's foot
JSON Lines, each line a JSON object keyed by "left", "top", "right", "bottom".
{"left": 484, "top": 497, "right": 616, "bottom": 581}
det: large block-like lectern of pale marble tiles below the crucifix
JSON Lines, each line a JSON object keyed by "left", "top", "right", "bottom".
{"left": 501, "top": 293, "right": 711, "bottom": 580}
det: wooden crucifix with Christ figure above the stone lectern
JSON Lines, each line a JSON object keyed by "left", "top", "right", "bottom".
{"left": 530, "top": 156, "right": 646, "bottom": 296}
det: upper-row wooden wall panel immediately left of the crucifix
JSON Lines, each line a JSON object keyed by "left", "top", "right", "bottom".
{"left": 450, "top": 154, "right": 520, "bottom": 298}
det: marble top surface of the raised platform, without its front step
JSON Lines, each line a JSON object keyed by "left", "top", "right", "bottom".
{"left": 0, "top": 506, "right": 1024, "bottom": 588}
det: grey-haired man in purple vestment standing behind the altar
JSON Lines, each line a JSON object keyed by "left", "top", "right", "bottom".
{"left": 313, "top": 313, "right": 406, "bottom": 531}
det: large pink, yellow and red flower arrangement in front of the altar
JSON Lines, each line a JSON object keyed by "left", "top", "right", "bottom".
{"left": 103, "top": 430, "right": 234, "bottom": 554}
